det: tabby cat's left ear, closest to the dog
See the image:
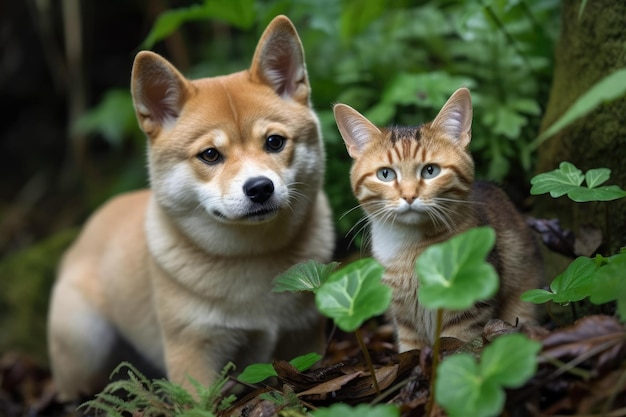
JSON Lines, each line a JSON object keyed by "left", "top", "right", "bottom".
{"left": 333, "top": 104, "right": 381, "bottom": 159}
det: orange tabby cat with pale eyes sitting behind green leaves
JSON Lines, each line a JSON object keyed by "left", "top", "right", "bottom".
{"left": 333, "top": 88, "right": 542, "bottom": 352}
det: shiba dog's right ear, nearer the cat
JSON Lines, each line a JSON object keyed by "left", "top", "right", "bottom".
{"left": 250, "top": 16, "right": 310, "bottom": 105}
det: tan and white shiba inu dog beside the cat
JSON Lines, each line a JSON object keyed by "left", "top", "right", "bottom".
{"left": 49, "top": 16, "right": 334, "bottom": 400}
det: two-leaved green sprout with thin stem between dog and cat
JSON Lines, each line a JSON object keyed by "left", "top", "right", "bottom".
{"left": 274, "top": 258, "right": 391, "bottom": 393}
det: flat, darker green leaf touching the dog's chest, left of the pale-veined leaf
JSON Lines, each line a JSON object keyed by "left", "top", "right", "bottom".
{"left": 272, "top": 260, "right": 339, "bottom": 292}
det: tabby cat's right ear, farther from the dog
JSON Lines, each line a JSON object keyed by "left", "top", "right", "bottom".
{"left": 431, "top": 88, "right": 472, "bottom": 146}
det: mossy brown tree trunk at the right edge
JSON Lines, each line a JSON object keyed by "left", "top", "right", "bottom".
{"left": 535, "top": 0, "right": 626, "bottom": 254}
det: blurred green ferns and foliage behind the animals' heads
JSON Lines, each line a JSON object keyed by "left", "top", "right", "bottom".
{"left": 77, "top": 0, "right": 559, "bottom": 240}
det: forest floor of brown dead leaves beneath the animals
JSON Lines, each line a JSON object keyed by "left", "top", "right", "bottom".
{"left": 0, "top": 314, "right": 626, "bottom": 417}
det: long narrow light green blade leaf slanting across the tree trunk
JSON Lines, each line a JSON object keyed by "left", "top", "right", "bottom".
{"left": 531, "top": 69, "right": 626, "bottom": 148}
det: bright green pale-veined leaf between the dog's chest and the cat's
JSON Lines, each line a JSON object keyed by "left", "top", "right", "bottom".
{"left": 315, "top": 258, "right": 391, "bottom": 332}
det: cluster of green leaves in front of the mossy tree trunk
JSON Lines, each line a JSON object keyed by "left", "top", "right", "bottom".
{"left": 530, "top": 162, "right": 626, "bottom": 203}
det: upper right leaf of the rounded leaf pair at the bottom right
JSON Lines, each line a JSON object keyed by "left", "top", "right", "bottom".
{"left": 480, "top": 333, "right": 541, "bottom": 388}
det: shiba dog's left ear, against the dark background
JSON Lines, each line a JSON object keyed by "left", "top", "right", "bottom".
{"left": 131, "top": 51, "right": 189, "bottom": 139}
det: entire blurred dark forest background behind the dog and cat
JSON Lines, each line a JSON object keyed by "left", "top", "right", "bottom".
{"left": 0, "top": 0, "right": 626, "bottom": 386}
